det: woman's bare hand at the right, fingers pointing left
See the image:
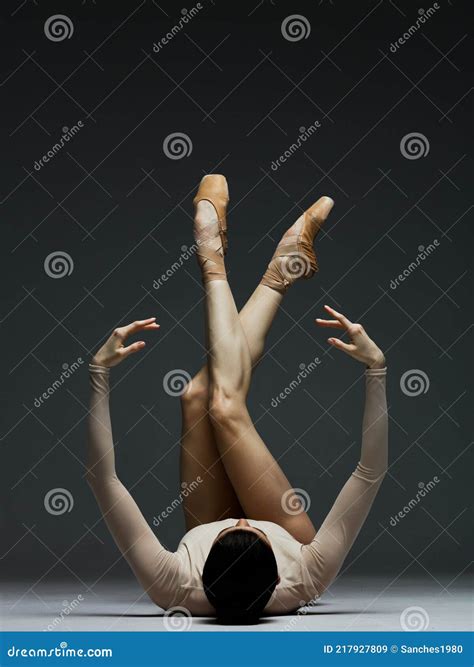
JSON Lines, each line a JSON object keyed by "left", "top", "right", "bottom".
{"left": 316, "top": 306, "right": 385, "bottom": 368}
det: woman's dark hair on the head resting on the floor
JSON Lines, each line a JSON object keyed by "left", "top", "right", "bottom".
{"left": 202, "top": 530, "right": 278, "bottom": 625}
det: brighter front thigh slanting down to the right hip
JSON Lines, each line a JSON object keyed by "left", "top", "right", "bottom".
{"left": 214, "top": 407, "right": 316, "bottom": 544}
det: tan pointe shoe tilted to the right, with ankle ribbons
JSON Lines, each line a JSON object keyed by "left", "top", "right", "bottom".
{"left": 260, "top": 197, "right": 334, "bottom": 294}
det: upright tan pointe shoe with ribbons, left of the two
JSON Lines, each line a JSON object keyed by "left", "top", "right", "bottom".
{"left": 193, "top": 174, "right": 229, "bottom": 282}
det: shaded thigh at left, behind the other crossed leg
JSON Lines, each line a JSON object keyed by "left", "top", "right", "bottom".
{"left": 180, "top": 402, "right": 244, "bottom": 530}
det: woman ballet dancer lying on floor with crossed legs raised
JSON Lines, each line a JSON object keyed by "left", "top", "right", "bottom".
{"left": 87, "top": 174, "right": 388, "bottom": 624}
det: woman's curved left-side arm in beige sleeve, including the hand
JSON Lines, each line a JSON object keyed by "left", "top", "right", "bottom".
{"left": 87, "top": 318, "right": 179, "bottom": 609}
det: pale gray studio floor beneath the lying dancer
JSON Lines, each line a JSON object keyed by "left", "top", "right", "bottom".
{"left": 0, "top": 575, "right": 473, "bottom": 632}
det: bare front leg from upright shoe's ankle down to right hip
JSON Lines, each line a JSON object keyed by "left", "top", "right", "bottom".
{"left": 183, "top": 197, "right": 315, "bottom": 542}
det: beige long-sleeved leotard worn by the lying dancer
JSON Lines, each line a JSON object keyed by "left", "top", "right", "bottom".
{"left": 87, "top": 364, "right": 388, "bottom": 615}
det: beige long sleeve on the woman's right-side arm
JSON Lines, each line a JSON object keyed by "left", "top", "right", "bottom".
{"left": 302, "top": 368, "right": 388, "bottom": 595}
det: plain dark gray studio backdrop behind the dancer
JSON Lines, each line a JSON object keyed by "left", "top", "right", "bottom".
{"left": 1, "top": 0, "right": 472, "bottom": 584}
